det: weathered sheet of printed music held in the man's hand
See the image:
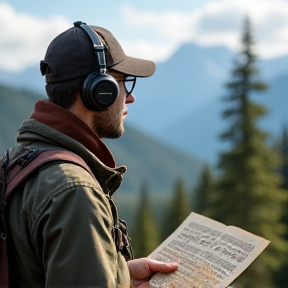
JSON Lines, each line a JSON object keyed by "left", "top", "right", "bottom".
{"left": 149, "top": 213, "right": 269, "bottom": 288}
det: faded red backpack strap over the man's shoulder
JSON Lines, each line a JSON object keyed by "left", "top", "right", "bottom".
{"left": 5, "top": 149, "right": 95, "bottom": 199}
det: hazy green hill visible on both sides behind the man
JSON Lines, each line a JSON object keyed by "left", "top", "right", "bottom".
{"left": 0, "top": 85, "right": 203, "bottom": 193}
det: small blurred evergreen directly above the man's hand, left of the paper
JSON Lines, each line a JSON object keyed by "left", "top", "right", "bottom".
{"left": 131, "top": 184, "right": 160, "bottom": 258}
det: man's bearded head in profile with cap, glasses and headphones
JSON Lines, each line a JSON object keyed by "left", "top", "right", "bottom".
{"left": 40, "top": 21, "right": 155, "bottom": 138}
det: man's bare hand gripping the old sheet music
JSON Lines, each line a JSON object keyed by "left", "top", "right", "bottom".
{"left": 128, "top": 258, "right": 178, "bottom": 288}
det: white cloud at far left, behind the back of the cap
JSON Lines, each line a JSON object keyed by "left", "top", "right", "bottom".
{"left": 0, "top": 3, "right": 71, "bottom": 72}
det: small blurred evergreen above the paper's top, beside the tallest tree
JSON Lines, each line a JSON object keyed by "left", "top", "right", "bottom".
{"left": 192, "top": 165, "right": 215, "bottom": 216}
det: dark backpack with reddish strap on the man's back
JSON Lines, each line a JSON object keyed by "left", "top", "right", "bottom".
{"left": 0, "top": 147, "right": 94, "bottom": 288}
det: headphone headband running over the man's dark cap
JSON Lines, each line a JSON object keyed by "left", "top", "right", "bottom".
{"left": 73, "top": 21, "right": 106, "bottom": 73}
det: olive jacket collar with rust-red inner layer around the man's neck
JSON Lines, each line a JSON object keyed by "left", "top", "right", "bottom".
{"left": 17, "top": 100, "right": 126, "bottom": 195}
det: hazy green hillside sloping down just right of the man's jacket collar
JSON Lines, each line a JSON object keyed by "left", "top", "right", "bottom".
{"left": 105, "top": 125, "right": 204, "bottom": 193}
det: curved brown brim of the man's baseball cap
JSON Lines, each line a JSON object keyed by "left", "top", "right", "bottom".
{"left": 112, "top": 56, "right": 156, "bottom": 77}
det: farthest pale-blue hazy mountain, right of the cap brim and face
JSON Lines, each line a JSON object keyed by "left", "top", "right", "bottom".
{"left": 129, "top": 43, "right": 233, "bottom": 133}
